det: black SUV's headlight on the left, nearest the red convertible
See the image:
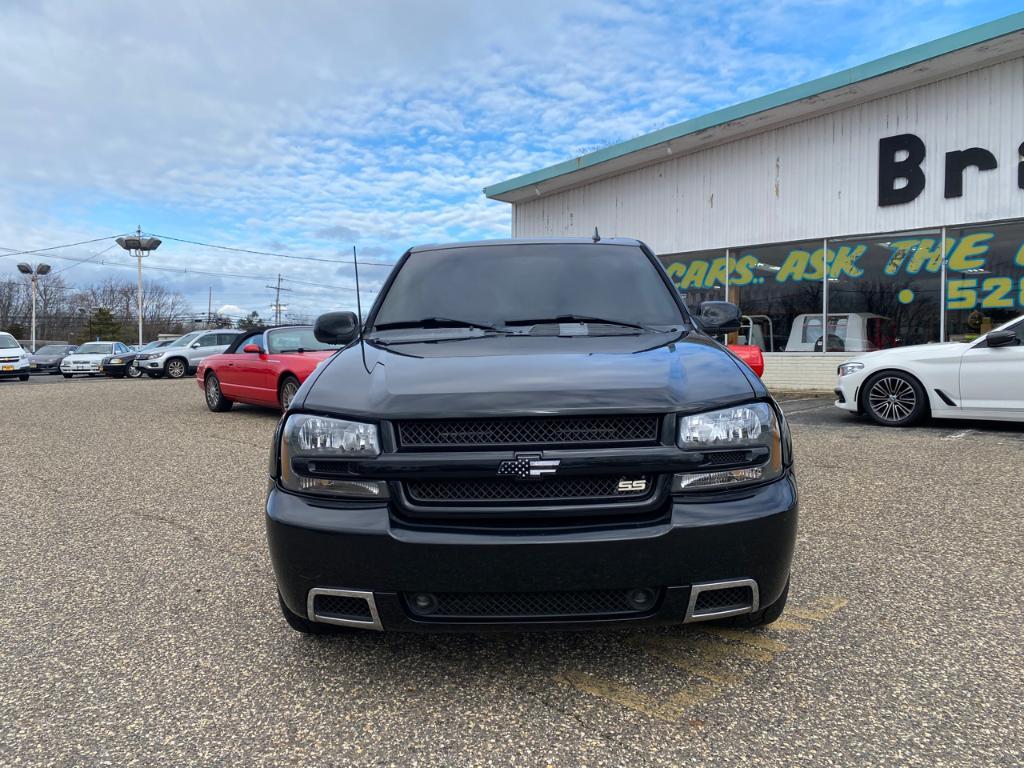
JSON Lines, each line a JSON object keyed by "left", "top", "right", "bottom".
{"left": 281, "top": 414, "right": 388, "bottom": 499}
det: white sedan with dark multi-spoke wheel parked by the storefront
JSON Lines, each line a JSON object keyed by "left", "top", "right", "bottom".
{"left": 836, "top": 316, "right": 1024, "bottom": 427}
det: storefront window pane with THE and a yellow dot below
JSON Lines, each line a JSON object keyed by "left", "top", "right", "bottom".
{"left": 828, "top": 230, "right": 942, "bottom": 352}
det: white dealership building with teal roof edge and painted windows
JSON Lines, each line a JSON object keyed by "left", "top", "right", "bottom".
{"left": 484, "top": 13, "right": 1024, "bottom": 389}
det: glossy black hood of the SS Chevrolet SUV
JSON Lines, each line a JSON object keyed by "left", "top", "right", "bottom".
{"left": 296, "top": 334, "right": 766, "bottom": 420}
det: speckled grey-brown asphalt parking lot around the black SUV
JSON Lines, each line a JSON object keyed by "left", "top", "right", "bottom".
{"left": 0, "top": 377, "right": 1024, "bottom": 766}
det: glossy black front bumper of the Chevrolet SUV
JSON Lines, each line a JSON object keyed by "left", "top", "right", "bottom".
{"left": 266, "top": 473, "right": 798, "bottom": 632}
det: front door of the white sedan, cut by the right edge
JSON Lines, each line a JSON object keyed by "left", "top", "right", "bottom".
{"left": 961, "top": 321, "right": 1024, "bottom": 420}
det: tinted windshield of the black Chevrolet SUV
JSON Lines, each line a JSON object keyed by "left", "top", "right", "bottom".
{"left": 374, "top": 243, "right": 684, "bottom": 330}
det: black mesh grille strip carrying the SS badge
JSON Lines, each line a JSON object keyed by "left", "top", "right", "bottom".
{"left": 406, "top": 475, "right": 654, "bottom": 504}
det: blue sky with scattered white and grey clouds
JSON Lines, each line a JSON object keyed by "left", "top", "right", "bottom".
{"left": 0, "top": 0, "right": 1020, "bottom": 317}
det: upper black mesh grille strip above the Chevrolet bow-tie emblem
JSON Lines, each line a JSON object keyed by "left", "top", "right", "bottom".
{"left": 395, "top": 415, "right": 660, "bottom": 449}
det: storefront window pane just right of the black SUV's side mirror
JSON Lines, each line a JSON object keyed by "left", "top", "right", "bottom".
{"left": 729, "top": 241, "right": 824, "bottom": 352}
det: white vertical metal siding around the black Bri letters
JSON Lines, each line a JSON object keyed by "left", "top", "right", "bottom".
{"left": 512, "top": 58, "right": 1024, "bottom": 253}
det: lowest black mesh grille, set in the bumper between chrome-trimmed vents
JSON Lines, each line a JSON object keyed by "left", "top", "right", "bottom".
{"left": 402, "top": 589, "right": 662, "bottom": 621}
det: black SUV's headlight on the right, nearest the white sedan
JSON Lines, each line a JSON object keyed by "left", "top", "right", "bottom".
{"left": 672, "top": 402, "right": 782, "bottom": 493}
